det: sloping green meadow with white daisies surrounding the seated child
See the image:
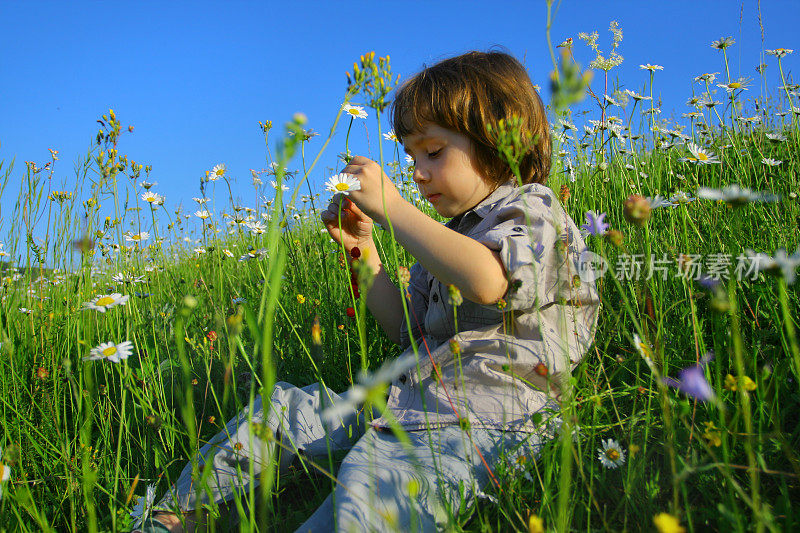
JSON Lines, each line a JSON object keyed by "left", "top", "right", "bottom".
{"left": 0, "top": 25, "right": 800, "bottom": 532}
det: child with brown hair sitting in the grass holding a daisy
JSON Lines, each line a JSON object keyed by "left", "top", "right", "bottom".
{"left": 141, "top": 52, "right": 599, "bottom": 532}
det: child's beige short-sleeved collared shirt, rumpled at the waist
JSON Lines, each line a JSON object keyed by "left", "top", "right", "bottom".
{"left": 373, "top": 181, "right": 600, "bottom": 431}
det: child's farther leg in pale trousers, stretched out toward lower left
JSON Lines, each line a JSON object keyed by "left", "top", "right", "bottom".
{"left": 156, "top": 382, "right": 363, "bottom": 524}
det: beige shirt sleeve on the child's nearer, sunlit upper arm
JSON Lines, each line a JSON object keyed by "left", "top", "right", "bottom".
{"left": 479, "top": 185, "right": 567, "bottom": 310}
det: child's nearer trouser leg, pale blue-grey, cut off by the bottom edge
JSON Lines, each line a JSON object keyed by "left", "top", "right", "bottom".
{"left": 297, "top": 426, "right": 541, "bottom": 533}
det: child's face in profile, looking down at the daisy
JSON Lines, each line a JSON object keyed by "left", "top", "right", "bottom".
{"left": 403, "top": 124, "right": 496, "bottom": 218}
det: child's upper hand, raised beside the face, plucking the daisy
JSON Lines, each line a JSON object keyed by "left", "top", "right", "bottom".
{"left": 342, "top": 155, "right": 404, "bottom": 226}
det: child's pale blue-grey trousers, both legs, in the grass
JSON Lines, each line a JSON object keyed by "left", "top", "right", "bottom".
{"left": 156, "top": 382, "right": 542, "bottom": 533}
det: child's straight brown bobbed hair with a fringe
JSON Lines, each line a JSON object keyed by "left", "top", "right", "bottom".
{"left": 391, "top": 51, "right": 550, "bottom": 184}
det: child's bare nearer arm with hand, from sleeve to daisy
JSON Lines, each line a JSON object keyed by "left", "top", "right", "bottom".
{"left": 342, "top": 156, "right": 508, "bottom": 309}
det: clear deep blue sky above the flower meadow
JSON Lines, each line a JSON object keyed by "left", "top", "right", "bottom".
{"left": 0, "top": 0, "right": 800, "bottom": 240}
